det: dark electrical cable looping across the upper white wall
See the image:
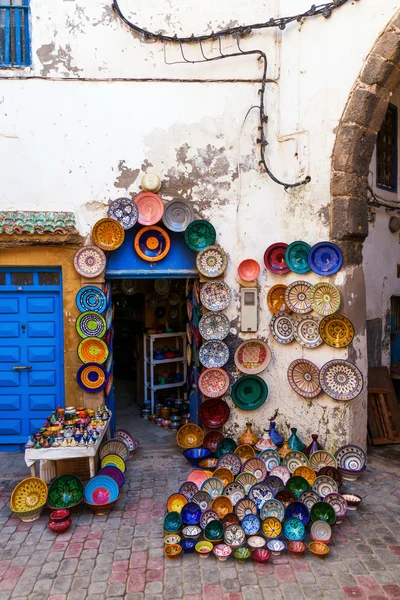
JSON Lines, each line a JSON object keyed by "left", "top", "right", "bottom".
{"left": 112, "top": 0, "right": 351, "bottom": 190}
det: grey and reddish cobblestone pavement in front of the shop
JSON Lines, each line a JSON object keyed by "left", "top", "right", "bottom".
{"left": 0, "top": 440, "right": 400, "bottom": 600}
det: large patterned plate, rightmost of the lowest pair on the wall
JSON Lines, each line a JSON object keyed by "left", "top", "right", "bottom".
{"left": 319, "top": 359, "right": 363, "bottom": 402}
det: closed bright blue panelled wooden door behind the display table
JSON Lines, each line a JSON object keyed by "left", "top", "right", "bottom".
{"left": 0, "top": 269, "right": 64, "bottom": 451}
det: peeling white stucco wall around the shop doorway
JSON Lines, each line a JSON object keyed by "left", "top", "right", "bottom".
{"left": 0, "top": 0, "right": 399, "bottom": 449}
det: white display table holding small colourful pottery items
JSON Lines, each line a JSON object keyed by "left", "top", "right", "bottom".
{"left": 25, "top": 413, "right": 112, "bottom": 483}
